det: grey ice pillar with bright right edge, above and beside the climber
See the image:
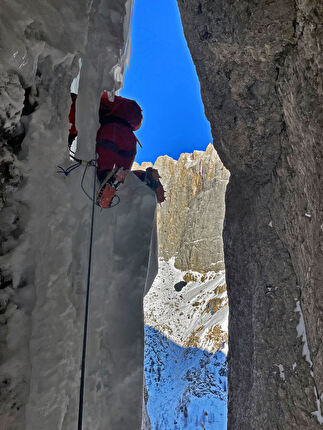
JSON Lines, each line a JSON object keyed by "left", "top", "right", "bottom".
{"left": 76, "top": 0, "right": 133, "bottom": 159}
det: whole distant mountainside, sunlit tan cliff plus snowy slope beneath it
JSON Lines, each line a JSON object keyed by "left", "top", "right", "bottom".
{"left": 140, "top": 144, "right": 229, "bottom": 430}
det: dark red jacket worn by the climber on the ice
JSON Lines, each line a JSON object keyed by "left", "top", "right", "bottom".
{"left": 96, "top": 93, "right": 142, "bottom": 173}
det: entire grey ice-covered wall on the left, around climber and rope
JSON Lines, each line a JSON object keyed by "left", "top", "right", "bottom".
{"left": 0, "top": 0, "right": 156, "bottom": 430}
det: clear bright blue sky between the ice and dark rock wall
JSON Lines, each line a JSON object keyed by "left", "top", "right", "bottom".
{"left": 121, "top": 0, "right": 212, "bottom": 163}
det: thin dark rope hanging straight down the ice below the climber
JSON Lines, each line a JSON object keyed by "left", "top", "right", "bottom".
{"left": 77, "top": 160, "right": 96, "bottom": 430}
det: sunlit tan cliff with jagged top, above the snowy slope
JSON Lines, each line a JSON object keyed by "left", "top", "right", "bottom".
{"left": 134, "top": 144, "right": 229, "bottom": 272}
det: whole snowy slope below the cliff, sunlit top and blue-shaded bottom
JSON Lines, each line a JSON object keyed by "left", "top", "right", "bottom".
{"left": 144, "top": 259, "right": 228, "bottom": 430}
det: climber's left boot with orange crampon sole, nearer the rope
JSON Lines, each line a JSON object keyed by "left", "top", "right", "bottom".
{"left": 96, "top": 167, "right": 127, "bottom": 208}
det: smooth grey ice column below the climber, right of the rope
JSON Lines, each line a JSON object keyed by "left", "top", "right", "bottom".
{"left": 81, "top": 174, "right": 158, "bottom": 430}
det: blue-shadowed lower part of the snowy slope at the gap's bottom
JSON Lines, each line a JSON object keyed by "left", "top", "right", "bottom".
{"left": 145, "top": 327, "right": 227, "bottom": 430}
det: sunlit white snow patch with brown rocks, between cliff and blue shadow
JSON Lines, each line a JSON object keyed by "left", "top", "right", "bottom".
{"left": 144, "top": 258, "right": 228, "bottom": 354}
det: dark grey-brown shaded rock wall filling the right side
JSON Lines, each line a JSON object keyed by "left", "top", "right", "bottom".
{"left": 178, "top": 0, "right": 323, "bottom": 430}
